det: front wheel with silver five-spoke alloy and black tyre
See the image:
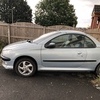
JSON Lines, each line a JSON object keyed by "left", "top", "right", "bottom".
{"left": 15, "top": 58, "right": 36, "bottom": 77}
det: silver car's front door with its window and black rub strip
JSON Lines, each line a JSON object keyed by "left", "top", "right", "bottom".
{"left": 41, "top": 34, "right": 87, "bottom": 70}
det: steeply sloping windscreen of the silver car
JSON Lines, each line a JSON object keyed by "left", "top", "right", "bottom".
{"left": 33, "top": 32, "right": 57, "bottom": 43}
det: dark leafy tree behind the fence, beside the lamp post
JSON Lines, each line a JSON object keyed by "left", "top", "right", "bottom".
{"left": 0, "top": 0, "right": 32, "bottom": 23}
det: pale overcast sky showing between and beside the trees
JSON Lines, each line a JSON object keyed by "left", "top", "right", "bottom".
{"left": 27, "top": 0, "right": 100, "bottom": 28}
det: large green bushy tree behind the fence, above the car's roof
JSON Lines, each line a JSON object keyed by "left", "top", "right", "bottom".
{"left": 35, "top": 0, "right": 77, "bottom": 26}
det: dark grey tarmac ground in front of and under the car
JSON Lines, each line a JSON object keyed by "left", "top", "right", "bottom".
{"left": 0, "top": 67, "right": 100, "bottom": 100}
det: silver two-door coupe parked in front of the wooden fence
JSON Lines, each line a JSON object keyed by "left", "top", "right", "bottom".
{"left": 1, "top": 30, "right": 100, "bottom": 77}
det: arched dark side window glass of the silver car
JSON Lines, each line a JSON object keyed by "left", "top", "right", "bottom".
{"left": 45, "top": 34, "right": 95, "bottom": 48}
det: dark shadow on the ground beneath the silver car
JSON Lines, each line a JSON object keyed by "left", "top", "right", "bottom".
{"left": 2, "top": 68, "right": 96, "bottom": 79}
